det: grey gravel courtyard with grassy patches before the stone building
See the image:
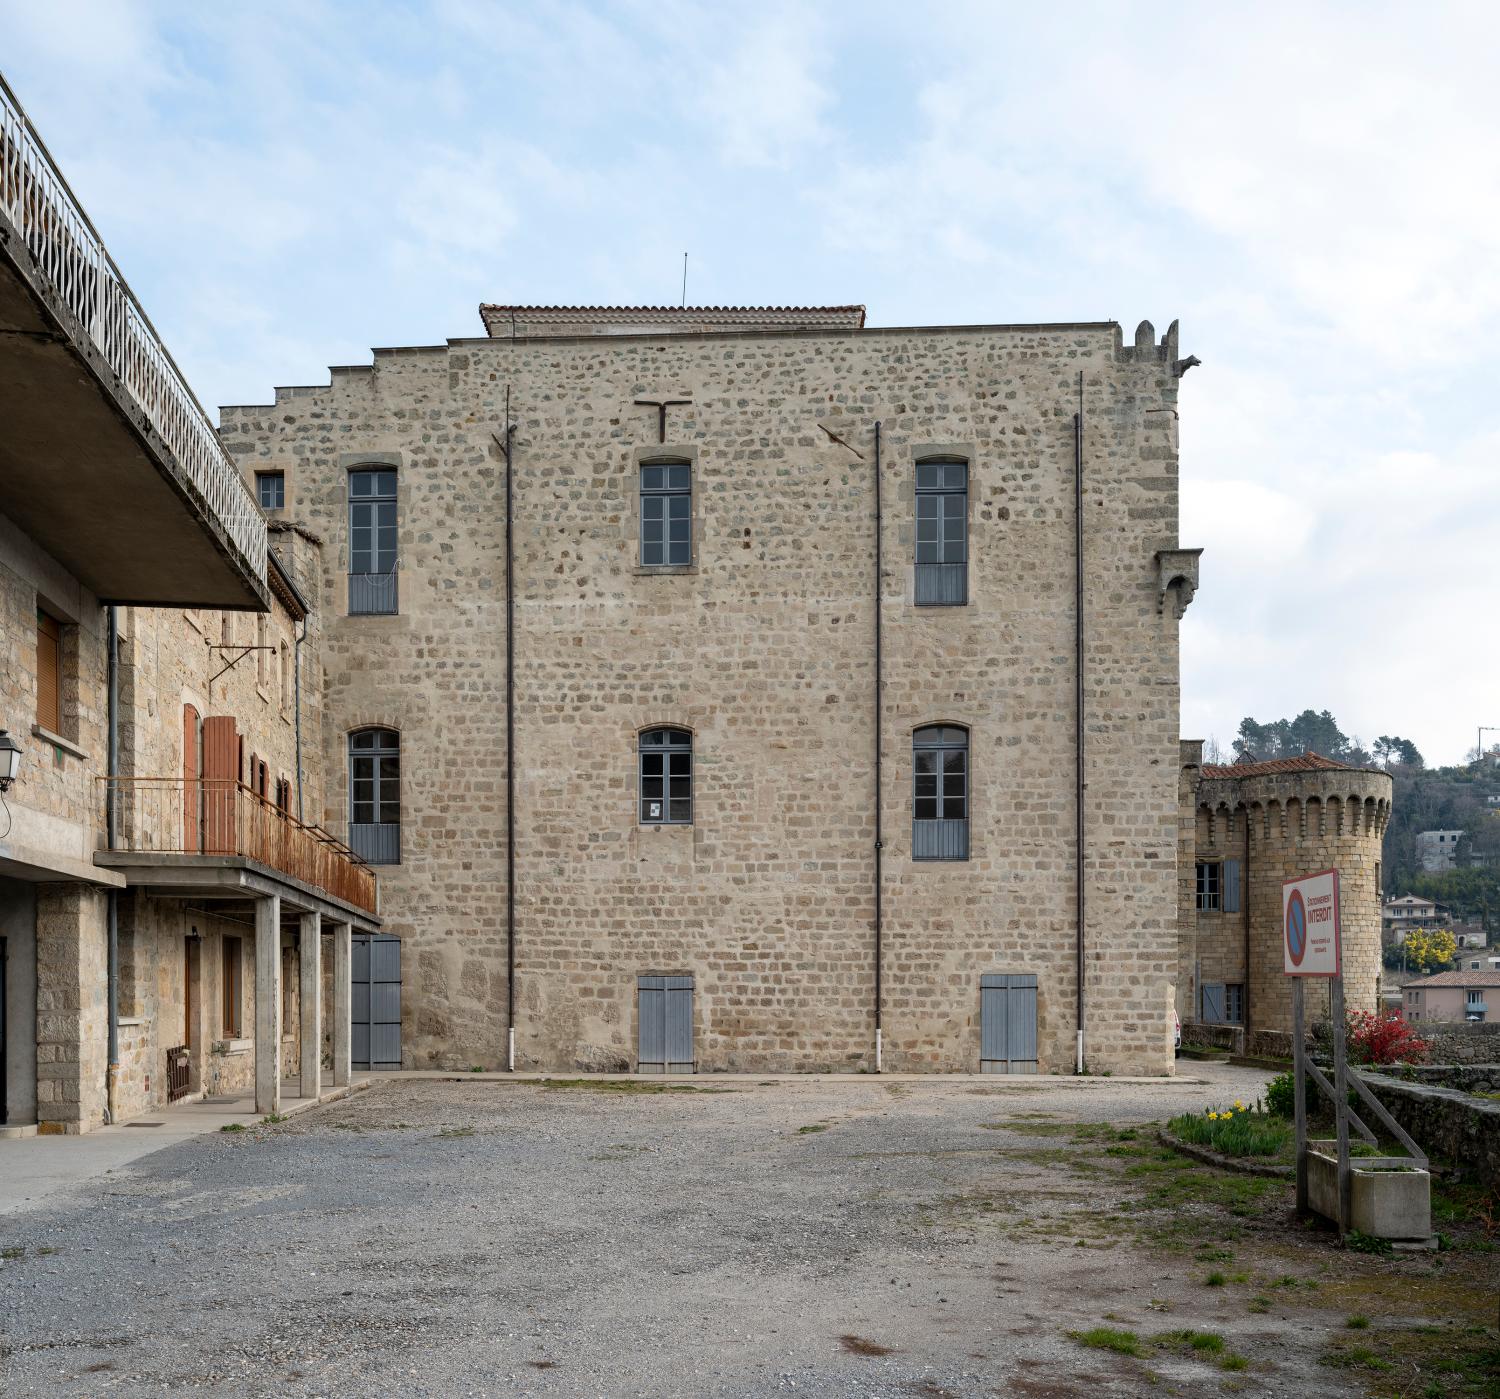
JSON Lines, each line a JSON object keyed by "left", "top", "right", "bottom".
{"left": 0, "top": 1066, "right": 1494, "bottom": 1399}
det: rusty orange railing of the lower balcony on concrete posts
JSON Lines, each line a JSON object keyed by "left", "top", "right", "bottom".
{"left": 101, "top": 777, "right": 377, "bottom": 913}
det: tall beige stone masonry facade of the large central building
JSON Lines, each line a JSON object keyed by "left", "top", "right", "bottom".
{"left": 222, "top": 325, "right": 1179, "bottom": 1072}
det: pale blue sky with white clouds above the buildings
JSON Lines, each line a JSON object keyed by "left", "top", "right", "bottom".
{"left": 0, "top": 0, "right": 1500, "bottom": 762}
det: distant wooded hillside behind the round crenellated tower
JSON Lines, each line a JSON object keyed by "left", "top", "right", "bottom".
{"left": 1205, "top": 709, "right": 1500, "bottom": 937}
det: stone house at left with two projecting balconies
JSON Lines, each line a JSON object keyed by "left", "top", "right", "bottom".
{"left": 0, "top": 82, "right": 378, "bottom": 1137}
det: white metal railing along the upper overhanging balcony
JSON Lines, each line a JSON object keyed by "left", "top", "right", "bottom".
{"left": 0, "top": 76, "right": 266, "bottom": 579}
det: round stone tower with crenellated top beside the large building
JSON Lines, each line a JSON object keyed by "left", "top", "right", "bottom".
{"left": 1178, "top": 744, "right": 1391, "bottom": 1041}
